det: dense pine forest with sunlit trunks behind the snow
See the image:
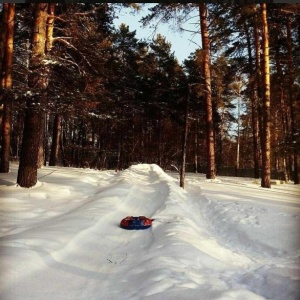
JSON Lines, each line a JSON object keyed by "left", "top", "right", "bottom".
{"left": 0, "top": 3, "right": 300, "bottom": 188}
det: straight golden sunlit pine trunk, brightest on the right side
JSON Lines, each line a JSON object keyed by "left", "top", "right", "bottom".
{"left": 260, "top": 3, "right": 271, "bottom": 188}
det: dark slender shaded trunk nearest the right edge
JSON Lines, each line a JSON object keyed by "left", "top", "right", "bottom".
{"left": 286, "top": 15, "right": 299, "bottom": 184}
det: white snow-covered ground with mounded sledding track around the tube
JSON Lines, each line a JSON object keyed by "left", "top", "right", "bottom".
{"left": 0, "top": 164, "right": 300, "bottom": 300}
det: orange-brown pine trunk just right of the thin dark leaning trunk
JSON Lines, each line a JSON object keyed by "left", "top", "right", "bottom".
{"left": 199, "top": 3, "right": 216, "bottom": 179}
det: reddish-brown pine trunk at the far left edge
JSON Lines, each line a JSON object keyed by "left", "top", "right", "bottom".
{"left": 0, "top": 3, "right": 15, "bottom": 173}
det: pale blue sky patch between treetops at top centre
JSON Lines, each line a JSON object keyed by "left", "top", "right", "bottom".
{"left": 114, "top": 4, "right": 201, "bottom": 62}
